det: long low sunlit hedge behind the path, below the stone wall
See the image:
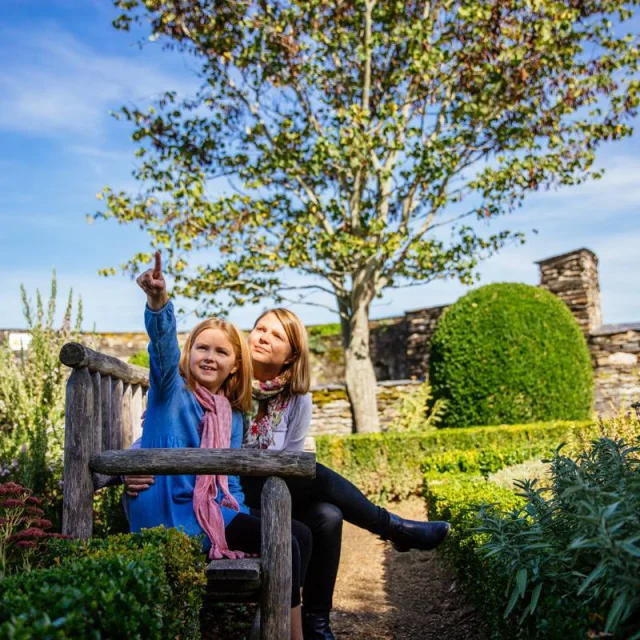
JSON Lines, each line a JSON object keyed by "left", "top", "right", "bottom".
{"left": 316, "top": 422, "right": 595, "bottom": 501}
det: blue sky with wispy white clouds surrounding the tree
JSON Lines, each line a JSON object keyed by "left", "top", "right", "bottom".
{"left": 0, "top": 0, "right": 640, "bottom": 331}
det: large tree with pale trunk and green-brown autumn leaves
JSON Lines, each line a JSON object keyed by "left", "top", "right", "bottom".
{"left": 96, "top": 0, "right": 638, "bottom": 431}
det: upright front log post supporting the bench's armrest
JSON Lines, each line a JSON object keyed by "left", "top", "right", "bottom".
{"left": 260, "top": 477, "right": 291, "bottom": 640}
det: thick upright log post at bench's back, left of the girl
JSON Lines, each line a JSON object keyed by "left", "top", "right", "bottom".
{"left": 62, "top": 368, "right": 95, "bottom": 539}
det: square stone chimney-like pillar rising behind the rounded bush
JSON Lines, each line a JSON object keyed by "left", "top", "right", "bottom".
{"left": 536, "top": 249, "right": 602, "bottom": 335}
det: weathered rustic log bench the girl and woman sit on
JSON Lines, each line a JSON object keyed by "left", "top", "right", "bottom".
{"left": 60, "top": 342, "right": 315, "bottom": 640}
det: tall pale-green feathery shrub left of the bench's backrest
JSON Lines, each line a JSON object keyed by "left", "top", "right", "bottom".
{"left": 0, "top": 273, "right": 82, "bottom": 524}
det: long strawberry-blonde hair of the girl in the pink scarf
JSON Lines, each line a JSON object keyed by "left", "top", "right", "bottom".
{"left": 179, "top": 318, "right": 253, "bottom": 412}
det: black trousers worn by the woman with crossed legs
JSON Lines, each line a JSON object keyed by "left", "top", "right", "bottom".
{"left": 241, "top": 464, "right": 389, "bottom": 612}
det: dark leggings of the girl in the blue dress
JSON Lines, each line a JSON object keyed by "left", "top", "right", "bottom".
{"left": 224, "top": 509, "right": 311, "bottom": 607}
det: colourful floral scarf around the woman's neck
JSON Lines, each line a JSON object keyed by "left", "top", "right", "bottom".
{"left": 243, "top": 371, "right": 291, "bottom": 449}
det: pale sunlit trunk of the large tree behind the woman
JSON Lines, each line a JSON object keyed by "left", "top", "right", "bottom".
{"left": 342, "top": 301, "right": 380, "bottom": 433}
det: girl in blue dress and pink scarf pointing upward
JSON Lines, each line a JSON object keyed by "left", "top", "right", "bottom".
{"left": 129, "top": 252, "right": 311, "bottom": 640}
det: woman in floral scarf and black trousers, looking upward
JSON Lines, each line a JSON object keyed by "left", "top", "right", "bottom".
{"left": 126, "top": 302, "right": 449, "bottom": 640}
